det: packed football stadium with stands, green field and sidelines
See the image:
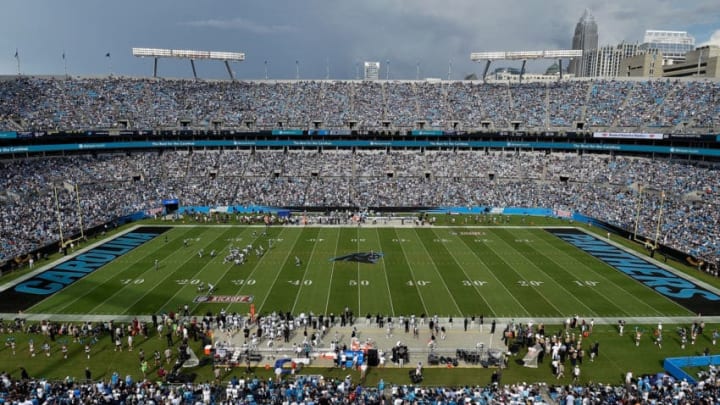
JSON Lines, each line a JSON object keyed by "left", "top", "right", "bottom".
{"left": 0, "top": 41, "right": 720, "bottom": 403}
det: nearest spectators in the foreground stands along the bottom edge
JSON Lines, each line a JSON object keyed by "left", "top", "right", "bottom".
{"left": 0, "top": 373, "right": 720, "bottom": 405}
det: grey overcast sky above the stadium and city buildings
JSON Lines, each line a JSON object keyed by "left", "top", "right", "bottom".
{"left": 0, "top": 0, "right": 720, "bottom": 79}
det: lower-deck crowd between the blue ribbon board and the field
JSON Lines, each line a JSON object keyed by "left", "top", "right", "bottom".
{"left": 0, "top": 150, "right": 720, "bottom": 271}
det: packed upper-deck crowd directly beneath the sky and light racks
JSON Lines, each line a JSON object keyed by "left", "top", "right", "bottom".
{"left": 0, "top": 77, "right": 720, "bottom": 131}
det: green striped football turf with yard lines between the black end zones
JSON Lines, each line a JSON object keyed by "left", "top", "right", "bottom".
{"left": 27, "top": 225, "right": 693, "bottom": 318}
